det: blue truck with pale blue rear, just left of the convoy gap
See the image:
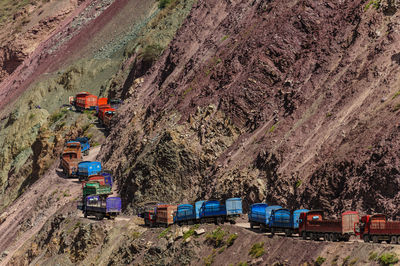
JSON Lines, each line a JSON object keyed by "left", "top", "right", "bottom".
{"left": 200, "top": 198, "right": 242, "bottom": 224}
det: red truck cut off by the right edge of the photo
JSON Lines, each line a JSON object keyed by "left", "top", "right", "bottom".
{"left": 355, "top": 214, "right": 400, "bottom": 244}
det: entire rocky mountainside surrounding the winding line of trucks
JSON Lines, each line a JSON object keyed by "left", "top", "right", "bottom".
{"left": 0, "top": 0, "right": 400, "bottom": 265}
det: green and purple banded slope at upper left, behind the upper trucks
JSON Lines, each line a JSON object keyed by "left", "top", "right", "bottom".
{"left": 0, "top": 0, "right": 193, "bottom": 213}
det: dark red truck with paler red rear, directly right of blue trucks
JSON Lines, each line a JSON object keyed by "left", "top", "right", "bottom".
{"left": 299, "top": 210, "right": 359, "bottom": 241}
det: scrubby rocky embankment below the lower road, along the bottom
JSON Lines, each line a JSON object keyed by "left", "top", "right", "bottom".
{"left": 9, "top": 214, "right": 400, "bottom": 265}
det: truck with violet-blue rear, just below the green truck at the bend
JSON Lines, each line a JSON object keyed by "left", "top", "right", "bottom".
{"left": 78, "top": 195, "right": 121, "bottom": 220}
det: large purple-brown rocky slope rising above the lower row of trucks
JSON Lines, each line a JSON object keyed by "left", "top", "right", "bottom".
{"left": 102, "top": 0, "right": 400, "bottom": 216}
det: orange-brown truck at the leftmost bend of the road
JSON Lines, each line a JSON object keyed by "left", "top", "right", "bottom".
{"left": 61, "top": 142, "right": 82, "bottom": 177}
